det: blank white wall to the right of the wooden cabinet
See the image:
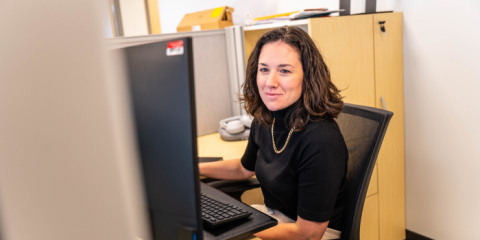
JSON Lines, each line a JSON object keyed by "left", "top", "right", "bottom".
{"left": 395, "top": 0, "right": 480, "bottom": 240}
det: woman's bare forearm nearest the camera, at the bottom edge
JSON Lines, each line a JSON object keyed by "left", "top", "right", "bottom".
{"left": 254, "top": 216, "right": 329, "bottom": 240}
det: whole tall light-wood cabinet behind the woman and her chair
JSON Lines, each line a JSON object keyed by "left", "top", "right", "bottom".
{"left": 244, "top": 13, "right": 405, "bottom": 240}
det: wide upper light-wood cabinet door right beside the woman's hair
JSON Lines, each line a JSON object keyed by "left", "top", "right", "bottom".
{"left": 308, "top": 15, "right": 375, "bottom": 107}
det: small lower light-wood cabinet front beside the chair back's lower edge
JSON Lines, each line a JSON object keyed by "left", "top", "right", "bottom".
{"left": 360, "top": 194, "right": 379, "bottom": 240}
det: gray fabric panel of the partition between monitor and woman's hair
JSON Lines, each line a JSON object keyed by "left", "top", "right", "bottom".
{"left": 193, "top": 35, "right": 233, "bottom": 136}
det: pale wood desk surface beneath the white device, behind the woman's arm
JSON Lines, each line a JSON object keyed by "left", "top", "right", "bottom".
{"left": 197, "top": 133, "right": 260, "bottom": 240}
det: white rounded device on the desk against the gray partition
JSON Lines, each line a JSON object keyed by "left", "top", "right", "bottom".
{"left": 218, "top": 115, "right": 253, "bottom": 141}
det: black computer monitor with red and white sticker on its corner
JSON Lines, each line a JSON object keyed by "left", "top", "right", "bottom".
{"left": 125, "top": 38, "right": 203, "bottom": 240}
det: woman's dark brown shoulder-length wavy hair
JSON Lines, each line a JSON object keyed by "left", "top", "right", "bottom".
{"left": 239, "top": 27, "right": 343, "bottom": 131}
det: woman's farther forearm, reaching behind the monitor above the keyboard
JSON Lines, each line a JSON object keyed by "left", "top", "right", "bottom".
{"left": 198, "top": 159, "right": 255, "bottom": 180}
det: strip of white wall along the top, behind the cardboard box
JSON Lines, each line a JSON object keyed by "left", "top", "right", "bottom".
{"left": 158, "top": 0, "right": 394, "bottom": 33}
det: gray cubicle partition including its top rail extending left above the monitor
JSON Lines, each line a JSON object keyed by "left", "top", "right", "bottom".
{"left": 107, "top": 29, "right": 240, "bottom": 136}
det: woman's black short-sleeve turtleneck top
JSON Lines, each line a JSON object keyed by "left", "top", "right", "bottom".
{"left": 241, "top": 108, "right": 348, "bottom": 231}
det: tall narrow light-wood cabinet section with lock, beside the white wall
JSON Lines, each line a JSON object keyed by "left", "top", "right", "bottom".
{"left": 373, "top": 13, "right": 405, "bottom": 240}
